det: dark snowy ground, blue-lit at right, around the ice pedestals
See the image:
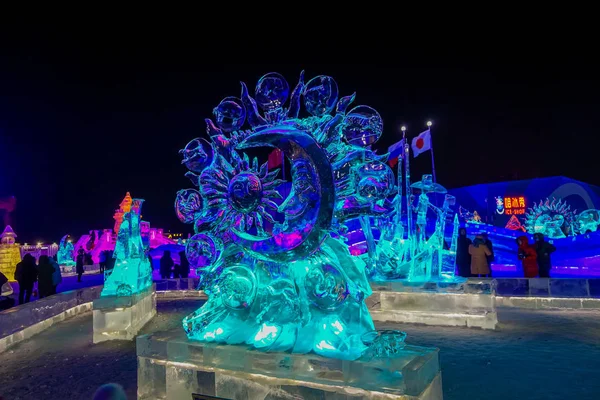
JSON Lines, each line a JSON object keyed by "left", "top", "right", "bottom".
{"left": 0, "top": 300, "right": 600, "bottom": 400}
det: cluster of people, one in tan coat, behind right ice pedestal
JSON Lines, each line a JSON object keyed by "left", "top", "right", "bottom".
{"left": 456, "top": 228, "right": 494, "bottom": 278}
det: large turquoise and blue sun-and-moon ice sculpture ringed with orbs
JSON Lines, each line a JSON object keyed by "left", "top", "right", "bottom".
{"left": 175, "top": 73, "right": 403, "bottom": 359}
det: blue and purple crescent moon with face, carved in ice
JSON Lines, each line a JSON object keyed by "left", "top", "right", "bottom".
{"left": 231, "top": 126, "right": 335, "bottom": 262}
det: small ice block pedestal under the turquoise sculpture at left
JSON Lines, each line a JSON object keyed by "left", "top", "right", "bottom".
{"left": 93, "top": 284, "right": 156, "bottom": 343}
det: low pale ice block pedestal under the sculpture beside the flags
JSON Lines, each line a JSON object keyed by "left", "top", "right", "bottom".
{"left": 366, "top": 279, "right": 498, "bottom": 329}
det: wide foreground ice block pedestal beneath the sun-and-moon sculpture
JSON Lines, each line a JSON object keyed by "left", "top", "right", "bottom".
{"left": 136, "top": 329, "right": 442, "bottom": 400}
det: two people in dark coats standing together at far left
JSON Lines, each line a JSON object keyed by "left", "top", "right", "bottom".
{"left": 14, "top": 254, "right": 62, "bottom": 304}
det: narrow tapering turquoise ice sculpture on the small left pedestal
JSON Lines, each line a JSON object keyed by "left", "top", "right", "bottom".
{"left": 100, "top": 199, "right": 152, "bottom": 296}
